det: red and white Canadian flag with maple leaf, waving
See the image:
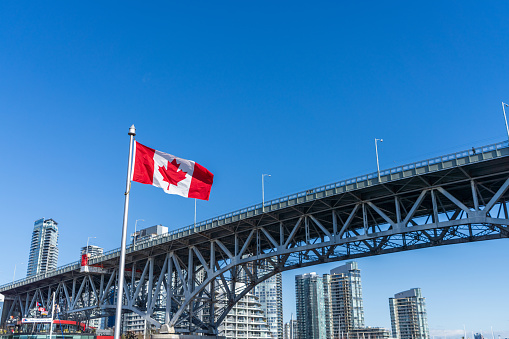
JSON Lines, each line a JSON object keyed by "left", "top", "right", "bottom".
{"left": 132, "top": 141, "right": 214, "bottom": 200}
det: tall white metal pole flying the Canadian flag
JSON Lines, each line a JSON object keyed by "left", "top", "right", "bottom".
{"left": 114, "top": 125, "right": 136, "bottom": 339}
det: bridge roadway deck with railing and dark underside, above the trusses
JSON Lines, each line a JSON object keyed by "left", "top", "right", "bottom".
{"left": 0, "top": 142, "right": 509, "bottom": 296}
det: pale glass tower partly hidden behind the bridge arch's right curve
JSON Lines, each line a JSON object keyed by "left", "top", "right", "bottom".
{"left": 254, "top": 273, "right": 283, "bottom": 339}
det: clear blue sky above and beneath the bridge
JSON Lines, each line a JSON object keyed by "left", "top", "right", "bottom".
{"left": 0, "top": 1, "right": 509, "bottom": 337}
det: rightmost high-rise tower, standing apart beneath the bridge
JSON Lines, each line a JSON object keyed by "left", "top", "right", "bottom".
{"left": 389, "top": 288, "right": 430, "bottom": 339}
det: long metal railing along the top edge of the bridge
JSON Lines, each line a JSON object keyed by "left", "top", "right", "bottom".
{"left": 0, "top": 141, "right": 509, "bottom": 289}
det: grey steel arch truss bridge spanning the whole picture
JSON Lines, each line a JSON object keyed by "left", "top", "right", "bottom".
{"left": 0, "top": 142, "right": 509, "bottom": 334}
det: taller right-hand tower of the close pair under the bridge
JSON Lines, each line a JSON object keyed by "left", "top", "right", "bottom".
{"left": 330, "top": 261, "right": 364, "bottom": 338}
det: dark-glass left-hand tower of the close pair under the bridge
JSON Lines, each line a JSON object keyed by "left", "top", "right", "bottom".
{"left": 295, "top": 272, "right": 327, "bottom": 339}
